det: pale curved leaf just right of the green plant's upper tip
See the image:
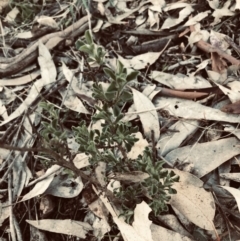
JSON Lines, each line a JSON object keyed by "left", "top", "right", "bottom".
{"left": 118, "top": 52, "right": 162, "bottom": 70}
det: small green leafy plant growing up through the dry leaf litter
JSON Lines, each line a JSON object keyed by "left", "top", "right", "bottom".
{"left": 39, "top": 31, "right": 178, "bottom": 224}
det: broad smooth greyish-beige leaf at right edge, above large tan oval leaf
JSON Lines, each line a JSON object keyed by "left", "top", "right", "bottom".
{"left": 165, "top": 137, "right": 240, "bottom": 178}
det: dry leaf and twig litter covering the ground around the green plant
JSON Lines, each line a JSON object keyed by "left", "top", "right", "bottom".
{"left": 0, "top": 0, "right": 240, "bottom": 241}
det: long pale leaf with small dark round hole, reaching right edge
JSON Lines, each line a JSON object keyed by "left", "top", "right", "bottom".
{"left": 154, "top": 97, "right": 239, "bottom": 123}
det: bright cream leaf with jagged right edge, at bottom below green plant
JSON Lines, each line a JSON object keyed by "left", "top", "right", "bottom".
{"left": 132, "top": 201, "right": 153, "bottom": 241}
